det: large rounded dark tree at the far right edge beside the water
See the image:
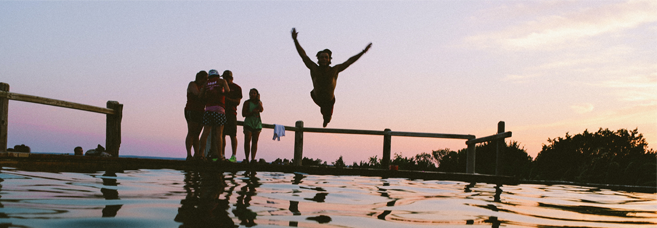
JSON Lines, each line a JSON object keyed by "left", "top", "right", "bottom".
{"left": 532, "top": 128, "right": 657, "bottom": 185}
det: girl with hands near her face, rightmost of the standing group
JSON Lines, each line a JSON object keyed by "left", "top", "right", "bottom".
{"left": 242, "top": 88, "right": 264, "bottom": 162}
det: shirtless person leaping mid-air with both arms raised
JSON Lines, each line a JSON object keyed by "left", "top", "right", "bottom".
{"left": 292, "top": 28, "right": 372, "bottom": 127}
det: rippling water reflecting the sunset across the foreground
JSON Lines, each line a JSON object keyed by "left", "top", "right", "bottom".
{"left": 0, "top": 167, "right": 657, "bottom": 228}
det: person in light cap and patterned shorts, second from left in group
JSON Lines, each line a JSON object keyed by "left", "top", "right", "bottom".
{"left": 199, "top": 69, "right": 230, "bottom": 160}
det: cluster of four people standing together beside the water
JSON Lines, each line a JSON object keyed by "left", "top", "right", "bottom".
{"left": 185, "top": 69, "right": 264, "bottom": 162}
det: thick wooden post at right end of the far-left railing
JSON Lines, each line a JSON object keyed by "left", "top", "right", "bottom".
{"left": 105, "top": 101, "right": 123, "bottom": 157}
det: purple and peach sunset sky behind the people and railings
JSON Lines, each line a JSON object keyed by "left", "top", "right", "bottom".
{"left": 0, "top": 0, "right": 657, "bottom": 164}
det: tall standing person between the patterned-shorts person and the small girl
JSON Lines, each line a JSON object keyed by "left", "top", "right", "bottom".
{"left": 221, "top": 70, "right": 242, "bottom": 162}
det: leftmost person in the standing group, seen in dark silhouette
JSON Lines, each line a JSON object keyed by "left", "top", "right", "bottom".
{"left": 185, "top": 70, "right": 208, "bottom": 160}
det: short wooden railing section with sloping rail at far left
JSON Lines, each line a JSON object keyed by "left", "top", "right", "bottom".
{"left": 0, "top": 82, "right": 123, "bottom": 157}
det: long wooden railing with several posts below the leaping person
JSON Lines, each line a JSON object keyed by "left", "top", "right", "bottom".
{"left": 237, "top": 120, "right": 511, "bottom": 175}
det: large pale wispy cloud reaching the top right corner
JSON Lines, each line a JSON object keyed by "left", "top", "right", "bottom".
{"left": 467, "top": 1, "right": 657, "bottom": 50}
